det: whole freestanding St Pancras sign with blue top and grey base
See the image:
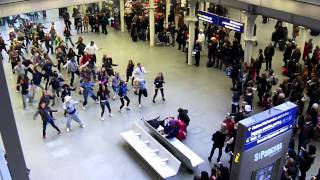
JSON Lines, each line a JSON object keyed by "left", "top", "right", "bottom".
{"left": 231, "top": 102, "right": 297, "bottom": 180}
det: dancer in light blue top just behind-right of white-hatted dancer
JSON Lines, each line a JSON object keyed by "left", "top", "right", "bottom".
{"left": 80, "top": 79, "right": 99, "bottom": 110}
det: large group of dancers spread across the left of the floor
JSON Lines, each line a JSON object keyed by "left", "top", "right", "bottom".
{"left": 0, "top": 9, "right": 170, "bottom": 140}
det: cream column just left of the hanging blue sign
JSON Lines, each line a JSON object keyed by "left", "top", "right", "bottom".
{"left": 186, "top": 0, "right": 198, "bottom": 65}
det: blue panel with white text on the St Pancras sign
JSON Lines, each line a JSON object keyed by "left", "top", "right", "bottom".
{"left": 244, "top": 108, "right": 296, "bottom": 150}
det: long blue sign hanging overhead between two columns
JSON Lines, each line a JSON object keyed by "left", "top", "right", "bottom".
{"left": 197, "top": 11, "right": 244, "bottom": 33}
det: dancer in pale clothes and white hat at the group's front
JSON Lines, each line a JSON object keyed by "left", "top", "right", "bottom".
{"left": 63, "top": 96, "right": 85, "bottom": 132}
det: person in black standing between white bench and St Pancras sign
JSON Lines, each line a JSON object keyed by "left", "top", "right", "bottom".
{"left": 208, "top": 124, "right": 227, "bottom": 162}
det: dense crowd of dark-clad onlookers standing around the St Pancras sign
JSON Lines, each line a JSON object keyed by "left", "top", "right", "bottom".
{"left": 195, "top": 19, "right": 320, "bottom": 180}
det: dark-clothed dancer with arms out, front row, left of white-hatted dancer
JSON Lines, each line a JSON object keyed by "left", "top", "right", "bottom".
{"left": 33, "top": 102, "right": 61, "bottom": 140}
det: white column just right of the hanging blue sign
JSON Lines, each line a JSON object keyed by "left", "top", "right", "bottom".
{"left": 243, "top": 13, "right": 257, "bottom": 62}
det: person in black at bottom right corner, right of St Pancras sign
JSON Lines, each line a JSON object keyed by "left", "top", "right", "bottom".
{"left": 299, "top": 144, "right": 317, "bottom": 180}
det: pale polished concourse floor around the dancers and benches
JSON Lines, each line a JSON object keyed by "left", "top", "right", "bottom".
{"left": 4, "top": 7, "right": 319, "bottom": 180}
